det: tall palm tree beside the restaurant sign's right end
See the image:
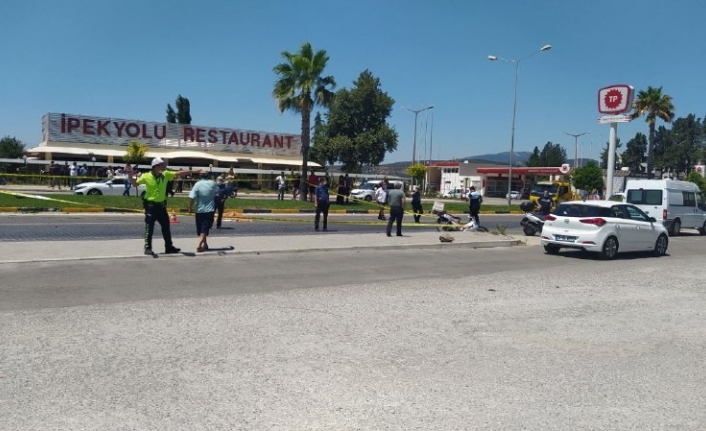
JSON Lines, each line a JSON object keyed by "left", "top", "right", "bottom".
{"left": 272, "top": 42, "right": 336, "bottom": 200}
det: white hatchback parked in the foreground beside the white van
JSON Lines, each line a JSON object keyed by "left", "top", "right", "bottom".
{"left": 541, "top": 201, "right": 669, "bottom": 259}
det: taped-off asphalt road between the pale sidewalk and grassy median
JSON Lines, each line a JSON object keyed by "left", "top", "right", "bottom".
{"left": 0, "top": 213, "right": 522, "bottom": 241}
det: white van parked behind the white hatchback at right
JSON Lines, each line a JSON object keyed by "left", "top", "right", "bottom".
{"left": 624, "top": 180, "right": 706, "bottom": 235}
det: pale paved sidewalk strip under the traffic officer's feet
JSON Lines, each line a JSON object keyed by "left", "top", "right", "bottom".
{"left": 0, "top": 232, "right": 527, "bottom": 264}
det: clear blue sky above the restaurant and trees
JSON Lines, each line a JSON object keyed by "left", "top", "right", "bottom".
{"left": 0, "top": 0, "right": 706, "bottom": 162}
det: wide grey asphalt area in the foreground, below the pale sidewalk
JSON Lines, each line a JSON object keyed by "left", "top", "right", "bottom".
{"left": 0, "top": 235, "right": 706, "bottom": 431}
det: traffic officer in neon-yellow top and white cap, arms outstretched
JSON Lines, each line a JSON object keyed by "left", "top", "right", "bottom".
{"left": 127, "top": 157, "right": 189, "bottom": 256}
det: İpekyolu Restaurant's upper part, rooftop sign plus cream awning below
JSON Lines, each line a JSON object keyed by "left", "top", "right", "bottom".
{"left": 26, "top": 113, "right": 320, "bottom": 171}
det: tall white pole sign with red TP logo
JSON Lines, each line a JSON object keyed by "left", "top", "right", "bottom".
{"left": 598, "top": 85, "right": 635, "bottom": 199}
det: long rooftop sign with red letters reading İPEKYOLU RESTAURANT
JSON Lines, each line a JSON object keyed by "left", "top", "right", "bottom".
{"left": 42, "top": 113, "right": 301, "bottom": 156}
